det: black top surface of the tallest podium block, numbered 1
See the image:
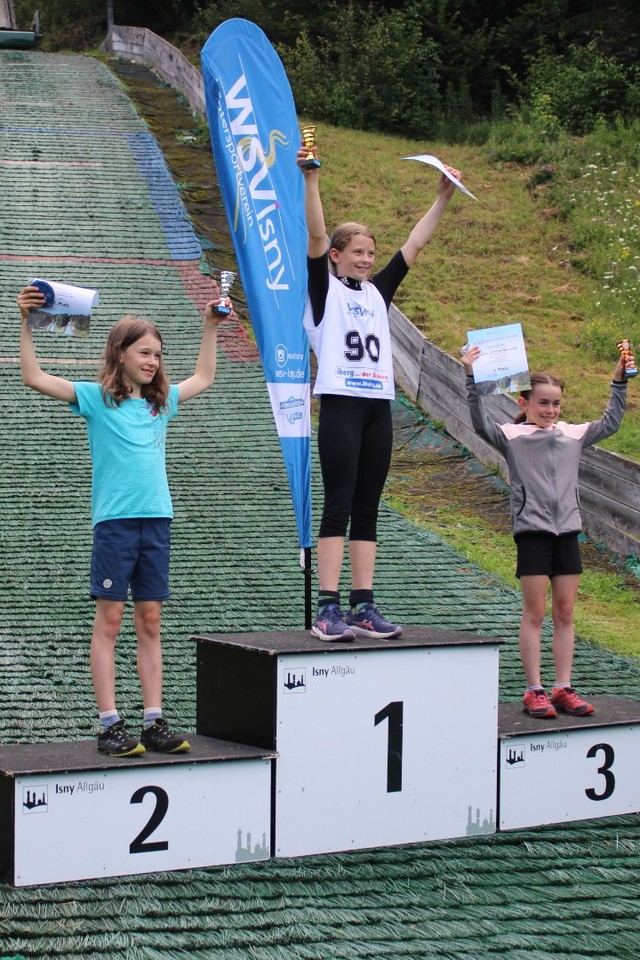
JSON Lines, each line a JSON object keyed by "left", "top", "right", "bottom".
{"left": 192, "top": 626, "right": 504, "bottom": 656}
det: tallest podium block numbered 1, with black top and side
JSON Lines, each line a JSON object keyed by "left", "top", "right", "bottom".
{"left": 196, "top": 627, "right": 501, "bottom": 857}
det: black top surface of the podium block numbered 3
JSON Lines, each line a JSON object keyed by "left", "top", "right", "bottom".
{"left": 498, "top": 697, "right": 640, "bottom": 739}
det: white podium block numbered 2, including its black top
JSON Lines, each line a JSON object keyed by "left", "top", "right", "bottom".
{"left": 0, "top": 736, "right": 274, "bottom": 886}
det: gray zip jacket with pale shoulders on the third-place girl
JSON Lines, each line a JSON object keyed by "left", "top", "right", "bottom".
{"left": 467, "top": 376, "right": 627, "bottom": 537}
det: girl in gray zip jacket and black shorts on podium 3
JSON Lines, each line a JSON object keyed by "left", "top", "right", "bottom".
{"left": 462, "top": 346, "right": 627, "bottom": 719}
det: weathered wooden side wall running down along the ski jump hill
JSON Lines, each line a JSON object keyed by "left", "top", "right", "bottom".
{"left": 104, "top": 26, "right": 640, "bottom": 557}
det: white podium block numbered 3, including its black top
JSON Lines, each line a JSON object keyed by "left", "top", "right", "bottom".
{"left": 498, "top": 697, "right": 640, "bottom": 830}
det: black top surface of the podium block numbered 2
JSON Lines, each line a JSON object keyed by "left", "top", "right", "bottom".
{"left": 0, "top": 734, "right": 277, "bottom": 777}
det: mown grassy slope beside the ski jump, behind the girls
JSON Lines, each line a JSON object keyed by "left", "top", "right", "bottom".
{"left": 310, "top": 125, "right": 640, "bottom": 655}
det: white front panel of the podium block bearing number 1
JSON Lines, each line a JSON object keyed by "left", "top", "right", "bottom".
{"left": 275, "top": 645, "right": 500, "bottom": 857}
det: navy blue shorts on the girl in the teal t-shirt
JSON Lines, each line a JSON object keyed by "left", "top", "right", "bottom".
{"left": 91, "top": 517, "right": 171, "bottom": 601}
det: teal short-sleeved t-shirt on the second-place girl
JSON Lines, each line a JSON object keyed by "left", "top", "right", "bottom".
{"left": 70, "top": 380, "right": 178, "bottom": 526}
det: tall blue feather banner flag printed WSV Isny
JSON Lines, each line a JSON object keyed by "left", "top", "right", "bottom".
{"left": 201, "top": 19, "right": 311, "bottom": 547}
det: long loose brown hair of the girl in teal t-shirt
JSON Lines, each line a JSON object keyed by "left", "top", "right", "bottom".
{"left": 98, "top": 316, "right": 169, "bottom": 413}
